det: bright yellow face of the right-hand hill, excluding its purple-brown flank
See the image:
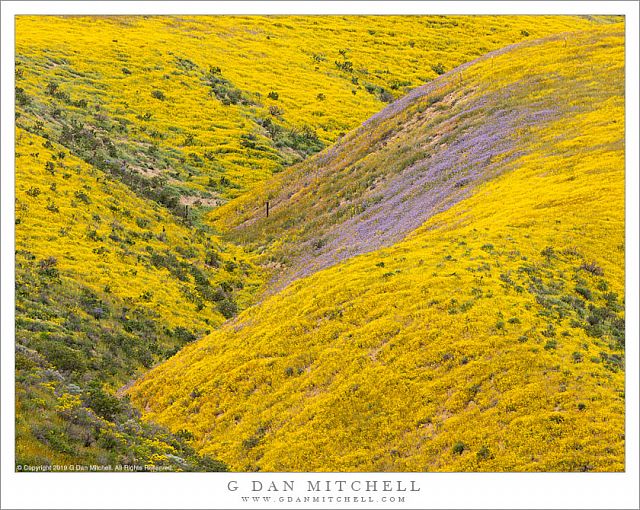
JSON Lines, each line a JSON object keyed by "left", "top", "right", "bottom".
{"left": 130, "top": 28, "right": 624, "bottom": 471}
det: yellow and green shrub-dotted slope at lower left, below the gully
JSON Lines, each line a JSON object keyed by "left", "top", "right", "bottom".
{"left": 16, "top": 129, "right": 261, "bottom": 469}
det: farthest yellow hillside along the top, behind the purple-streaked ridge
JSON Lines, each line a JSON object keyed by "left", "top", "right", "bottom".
{"left": 16, "top": 16, "right": 593, "bottom": 206}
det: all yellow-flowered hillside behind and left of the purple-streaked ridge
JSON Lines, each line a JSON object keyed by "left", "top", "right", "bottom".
{"left": 15, "top": 17, "right": 608, "bottom": 469}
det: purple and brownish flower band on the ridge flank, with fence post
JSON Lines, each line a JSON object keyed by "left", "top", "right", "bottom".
{"left": 211, "top": 25, "right": 624, "bottom": 289}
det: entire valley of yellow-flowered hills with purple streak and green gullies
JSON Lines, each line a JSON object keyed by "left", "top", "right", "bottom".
{"left": 15, "top": 16, "right": 625, "bottom": 471}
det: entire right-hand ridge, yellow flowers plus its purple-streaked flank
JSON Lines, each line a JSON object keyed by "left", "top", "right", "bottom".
{"left": 129, "top": 25, "right": 625, "bottom": 471}
